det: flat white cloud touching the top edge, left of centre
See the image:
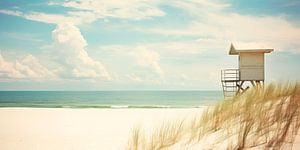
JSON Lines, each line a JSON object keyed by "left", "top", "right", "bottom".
{"left": 63, "top": 0, "right": 165, "bottom": 20}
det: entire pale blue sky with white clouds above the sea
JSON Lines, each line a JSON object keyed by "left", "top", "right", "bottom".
{"left": 0, "top": 0, "right": 300, "bottom": 91}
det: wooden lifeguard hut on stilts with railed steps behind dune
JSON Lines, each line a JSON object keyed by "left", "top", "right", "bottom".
{"left": 221, "top": 44, "right": 273, "bottom": 98}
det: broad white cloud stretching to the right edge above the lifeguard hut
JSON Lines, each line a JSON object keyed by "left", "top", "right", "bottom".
{"left": 132, "top": 1, "right": 300, "bottom": 53}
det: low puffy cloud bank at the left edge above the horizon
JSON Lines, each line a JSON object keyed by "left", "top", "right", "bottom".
{"left": 0, "top": 53, "right": 57, "bottom": 80}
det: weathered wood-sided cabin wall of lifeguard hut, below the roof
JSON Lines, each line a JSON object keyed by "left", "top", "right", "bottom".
{"left": 239, "top": 53, "right": 265, "bottom": 80}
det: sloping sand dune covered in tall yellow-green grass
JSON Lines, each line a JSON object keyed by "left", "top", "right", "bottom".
{"left": 127, "top": 82, "right": 300, "bottom": 150}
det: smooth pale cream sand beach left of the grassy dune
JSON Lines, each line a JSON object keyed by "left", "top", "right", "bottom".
{"left": 0, "top": 108, "right": 203, "bottom": 150}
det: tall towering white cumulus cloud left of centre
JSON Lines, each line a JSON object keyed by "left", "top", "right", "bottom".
{"left": 52, "top": 23, "right": 111, "bottom": 79}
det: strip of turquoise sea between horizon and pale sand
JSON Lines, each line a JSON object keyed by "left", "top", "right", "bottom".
{"left": 0, "top": 91, "right": 223, "bottom": 108}
